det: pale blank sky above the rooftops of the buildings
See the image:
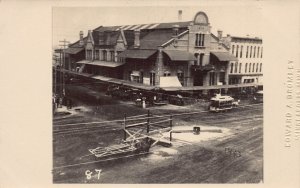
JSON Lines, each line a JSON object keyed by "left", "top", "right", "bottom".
{"left": 52, "top": 3, "right": 262, "bottom": 47}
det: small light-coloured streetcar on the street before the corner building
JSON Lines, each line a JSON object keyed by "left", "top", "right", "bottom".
{"left": 209, "top": 94, "right": 239, "bottom": 112}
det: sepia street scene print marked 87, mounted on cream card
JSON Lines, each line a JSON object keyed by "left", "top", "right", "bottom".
{"left": 49, "top": 4, "right": 265, "bottom": 184}
